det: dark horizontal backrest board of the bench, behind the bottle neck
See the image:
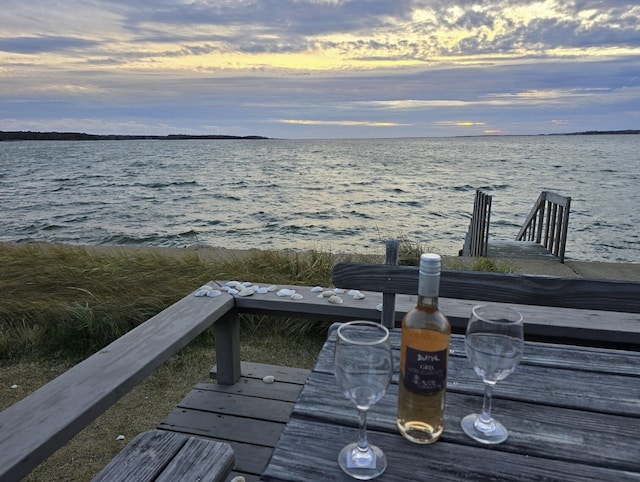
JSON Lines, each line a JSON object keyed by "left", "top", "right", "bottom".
{"left": 332, "top": 262, "right": 640, "bottom": 313}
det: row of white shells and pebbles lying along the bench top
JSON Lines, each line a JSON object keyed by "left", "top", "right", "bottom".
{"left": 195, "top": 281, "right": 365, "bottom": 304}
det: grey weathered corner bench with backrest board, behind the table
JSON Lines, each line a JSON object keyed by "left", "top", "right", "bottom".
{"left": 0, "top": 241, "right": 640, "bottom": 482}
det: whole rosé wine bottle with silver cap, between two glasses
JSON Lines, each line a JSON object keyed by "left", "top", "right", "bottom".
{"left": 397, "top": 254, "right": 451, "bottom": 444}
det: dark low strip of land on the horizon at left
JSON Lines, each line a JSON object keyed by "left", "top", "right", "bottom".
{"left": 0, "top": 131, "right": 268, "bottom": 141}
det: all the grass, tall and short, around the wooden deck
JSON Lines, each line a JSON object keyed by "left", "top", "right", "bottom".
{"left": 0, "top": 242, "right": 508, "bottom": 481}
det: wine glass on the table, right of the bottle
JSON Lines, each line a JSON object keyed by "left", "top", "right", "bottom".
{"left": 461, "top": 304, "right": 524, "bottom": 444}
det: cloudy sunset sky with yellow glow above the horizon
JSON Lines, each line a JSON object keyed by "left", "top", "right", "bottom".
{"left": 0, "top": 0, "right": 640, "bottom": 138}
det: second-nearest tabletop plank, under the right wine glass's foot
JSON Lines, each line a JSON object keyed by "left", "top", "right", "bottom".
{"left": 293, "top": 374, "right": 640, "bottom": 456}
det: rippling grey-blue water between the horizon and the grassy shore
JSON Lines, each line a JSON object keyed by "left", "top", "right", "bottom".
{"left": 0, "top": 135, "right": 640, "bottom": 262}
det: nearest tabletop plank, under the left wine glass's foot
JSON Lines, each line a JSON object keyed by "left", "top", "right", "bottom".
{"left": 262, "top": 416, "right": 638, "bottom": 482}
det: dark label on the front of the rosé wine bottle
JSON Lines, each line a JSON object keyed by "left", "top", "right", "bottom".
{"left": 404, "top": 346, "right": 447, "bottom": 395}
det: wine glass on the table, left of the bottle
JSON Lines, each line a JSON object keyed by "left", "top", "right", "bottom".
{"left": 334, "top": 321, "right": 393, "bottom": 480}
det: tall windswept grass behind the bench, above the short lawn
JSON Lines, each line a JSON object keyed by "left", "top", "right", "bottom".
{"left": 0, "top": 245, "right": 378, "bottom": 360}
